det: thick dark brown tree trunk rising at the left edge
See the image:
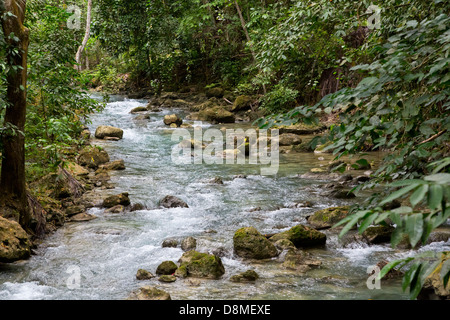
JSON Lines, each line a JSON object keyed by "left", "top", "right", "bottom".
{"left": 0, "top": 0, "right": 31, "bottom": 227}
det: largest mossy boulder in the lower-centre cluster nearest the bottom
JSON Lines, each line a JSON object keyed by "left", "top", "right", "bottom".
{"left": 175, "top": 250, "right": 225, "bottom": 279}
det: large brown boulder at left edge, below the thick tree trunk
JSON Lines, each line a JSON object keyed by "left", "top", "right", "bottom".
{"left": 0, "top": 217, "right": 31, "bottom": 263}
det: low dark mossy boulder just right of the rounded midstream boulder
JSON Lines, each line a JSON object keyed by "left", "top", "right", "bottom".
{"left": 269, "top": 224, "right": 327, "bottom": 248}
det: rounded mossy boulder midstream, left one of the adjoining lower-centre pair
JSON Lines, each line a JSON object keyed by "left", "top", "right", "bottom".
{"left": 233, "top": 227, "right": 278, "bottom": 259}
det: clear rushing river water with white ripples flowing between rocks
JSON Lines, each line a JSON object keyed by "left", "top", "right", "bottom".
{"left": 0, "top": 97, "right": 450, "bottom": 300}
